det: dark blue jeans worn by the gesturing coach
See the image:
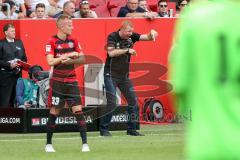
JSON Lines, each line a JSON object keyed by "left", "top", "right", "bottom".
{"left": 99, "top": 76, "right": 139, "bottom": 132}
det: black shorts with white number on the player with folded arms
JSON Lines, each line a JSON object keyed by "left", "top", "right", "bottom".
{"left": 48, "top": 80, "right": 82, "bottom": 108}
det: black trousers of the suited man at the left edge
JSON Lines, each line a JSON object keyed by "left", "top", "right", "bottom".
{"left": 0, "top": 75, "right": 18, "bottom": 108}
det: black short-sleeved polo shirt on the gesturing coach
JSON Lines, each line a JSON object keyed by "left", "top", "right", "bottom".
{"left": 104, "top": 31, "right": 141, "bottom": 77}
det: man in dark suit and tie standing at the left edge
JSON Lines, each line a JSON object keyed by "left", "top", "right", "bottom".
{"left": 0, "top": 23, "right": 27, "bottom": 108}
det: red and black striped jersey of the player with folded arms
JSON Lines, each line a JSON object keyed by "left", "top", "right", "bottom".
{"left": 46, "top": 35, "right": 82, "bottom": 82}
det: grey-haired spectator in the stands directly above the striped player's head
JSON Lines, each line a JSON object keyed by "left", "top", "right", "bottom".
{"left": 53, "top": 1, "right": 75, "bottom": 18}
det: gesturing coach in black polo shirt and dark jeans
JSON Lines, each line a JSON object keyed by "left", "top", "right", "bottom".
{"left": 100, "top": 21, "right": 158, "bottom": 136}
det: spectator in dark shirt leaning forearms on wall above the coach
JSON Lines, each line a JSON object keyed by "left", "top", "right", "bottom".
{"left": 117, "top": 0, "right": 157, "bottom": 19}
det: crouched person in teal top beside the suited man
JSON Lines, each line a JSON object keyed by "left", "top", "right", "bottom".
{"left": 16, "top": 65, "right": 43, "bottom": 108}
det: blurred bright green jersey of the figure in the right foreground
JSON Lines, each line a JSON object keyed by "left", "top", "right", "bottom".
{"left": 170, "top": 0, "right": 240, "bottom": 160}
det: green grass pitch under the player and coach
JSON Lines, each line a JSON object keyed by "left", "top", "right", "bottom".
{"left": 0, "top": 124, "right": 184, "bottom": 160}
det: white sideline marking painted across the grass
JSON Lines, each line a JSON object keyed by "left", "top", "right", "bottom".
{"left": 0, "top": 134, "right": 182, "bottom": 142}
